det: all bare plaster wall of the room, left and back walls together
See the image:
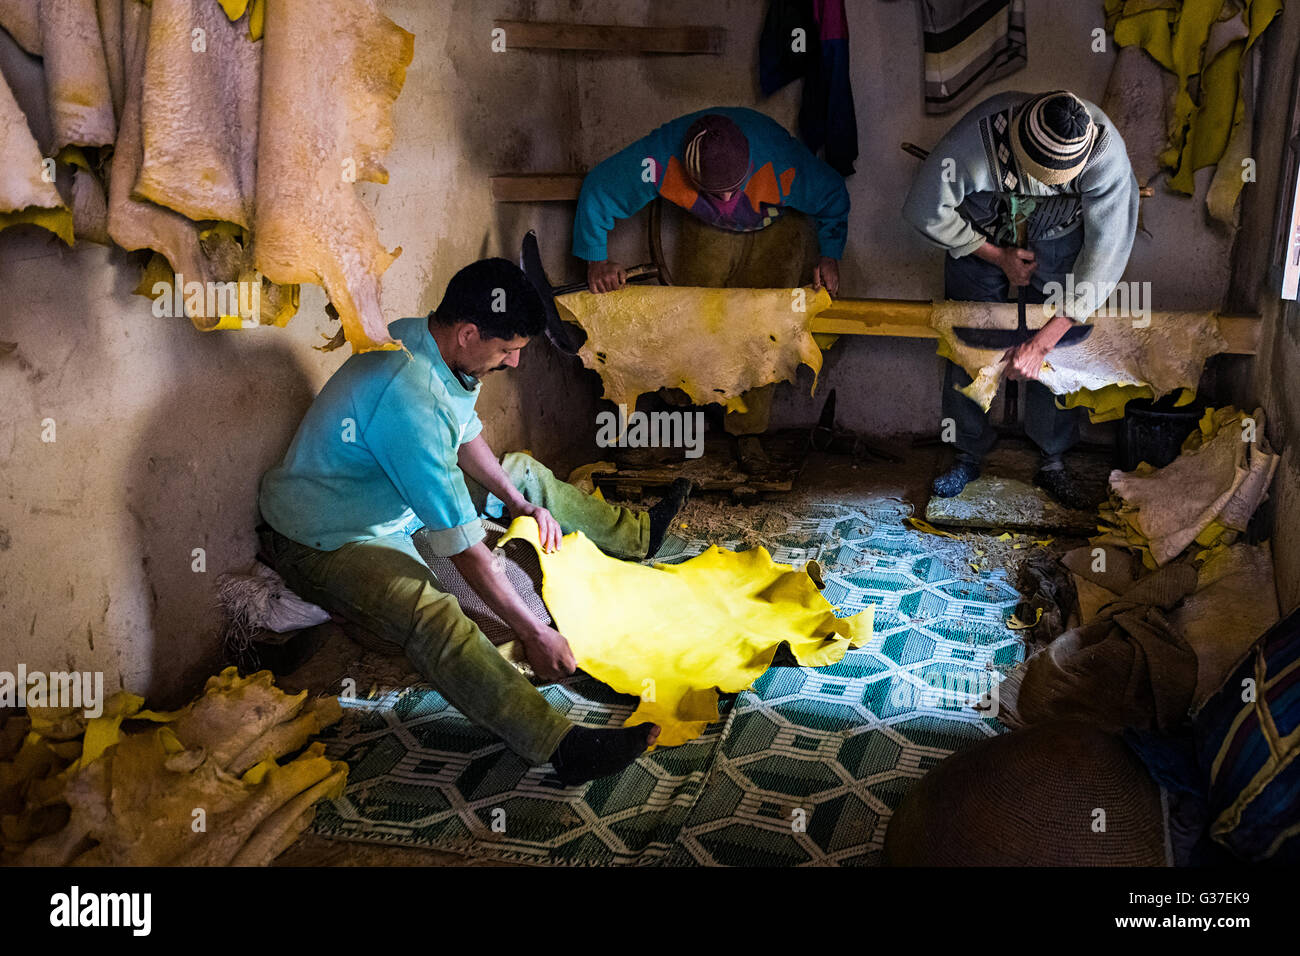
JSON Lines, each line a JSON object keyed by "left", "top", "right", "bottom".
{"left": 0, "top": 0, "right": 1253, "bottom": 697}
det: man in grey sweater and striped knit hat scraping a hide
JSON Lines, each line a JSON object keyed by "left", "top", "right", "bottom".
{"left": 904, "top": 90, "right": 1138, "bottom": 507}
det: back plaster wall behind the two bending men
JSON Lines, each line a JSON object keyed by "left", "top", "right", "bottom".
{"left": 575, "top": 0, "right": 1231, "bottom": 436}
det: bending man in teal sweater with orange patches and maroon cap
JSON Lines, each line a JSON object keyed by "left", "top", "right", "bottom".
{"left": 573, "top": 107, "right": 849, "bottom": 472}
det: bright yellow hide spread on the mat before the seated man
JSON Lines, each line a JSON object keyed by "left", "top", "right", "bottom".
{"left": 498, "top": 518, "right": 872, "bottom": 747}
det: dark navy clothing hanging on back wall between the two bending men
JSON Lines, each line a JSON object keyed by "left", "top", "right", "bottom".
{"left": 758, "top": 0, "right": 858, "bottom": 176}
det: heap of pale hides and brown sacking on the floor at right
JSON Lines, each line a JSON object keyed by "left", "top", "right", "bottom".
{"left": 998, "top": 407, "right": 1278, "bottom": 732}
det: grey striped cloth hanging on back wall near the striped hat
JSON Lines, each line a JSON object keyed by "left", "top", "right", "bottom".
{"left": 920, "top": 0, "right": 1028, "bottom": 114}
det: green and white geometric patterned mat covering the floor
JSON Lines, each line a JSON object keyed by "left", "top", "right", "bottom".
{"left": 313, "top": 501, "right": 1022, "bottom": 865}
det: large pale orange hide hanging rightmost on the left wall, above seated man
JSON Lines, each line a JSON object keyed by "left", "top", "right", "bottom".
{"left": 254, "top": 0, "right": 415, "bottom": 352}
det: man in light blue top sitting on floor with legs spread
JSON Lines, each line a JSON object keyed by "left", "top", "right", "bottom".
{"left": 259, "top": 259, "right": 689, "bottom": 784}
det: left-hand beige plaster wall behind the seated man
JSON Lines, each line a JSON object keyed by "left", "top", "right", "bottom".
{"left": 0, "top": 0, "right": 594, "bottom": 696}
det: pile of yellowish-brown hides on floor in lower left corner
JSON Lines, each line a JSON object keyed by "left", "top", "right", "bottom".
{"left": 0, "top": 667, "right": 347, "bottom": 866}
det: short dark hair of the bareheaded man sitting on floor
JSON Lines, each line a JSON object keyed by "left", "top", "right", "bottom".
{"left": 429, "top": 259, "right": 546, "bottom": 339}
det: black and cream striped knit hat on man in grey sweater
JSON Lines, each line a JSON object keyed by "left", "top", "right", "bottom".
{"left": 1011, "top": 90, "right": 1097, "bottom": 186}
